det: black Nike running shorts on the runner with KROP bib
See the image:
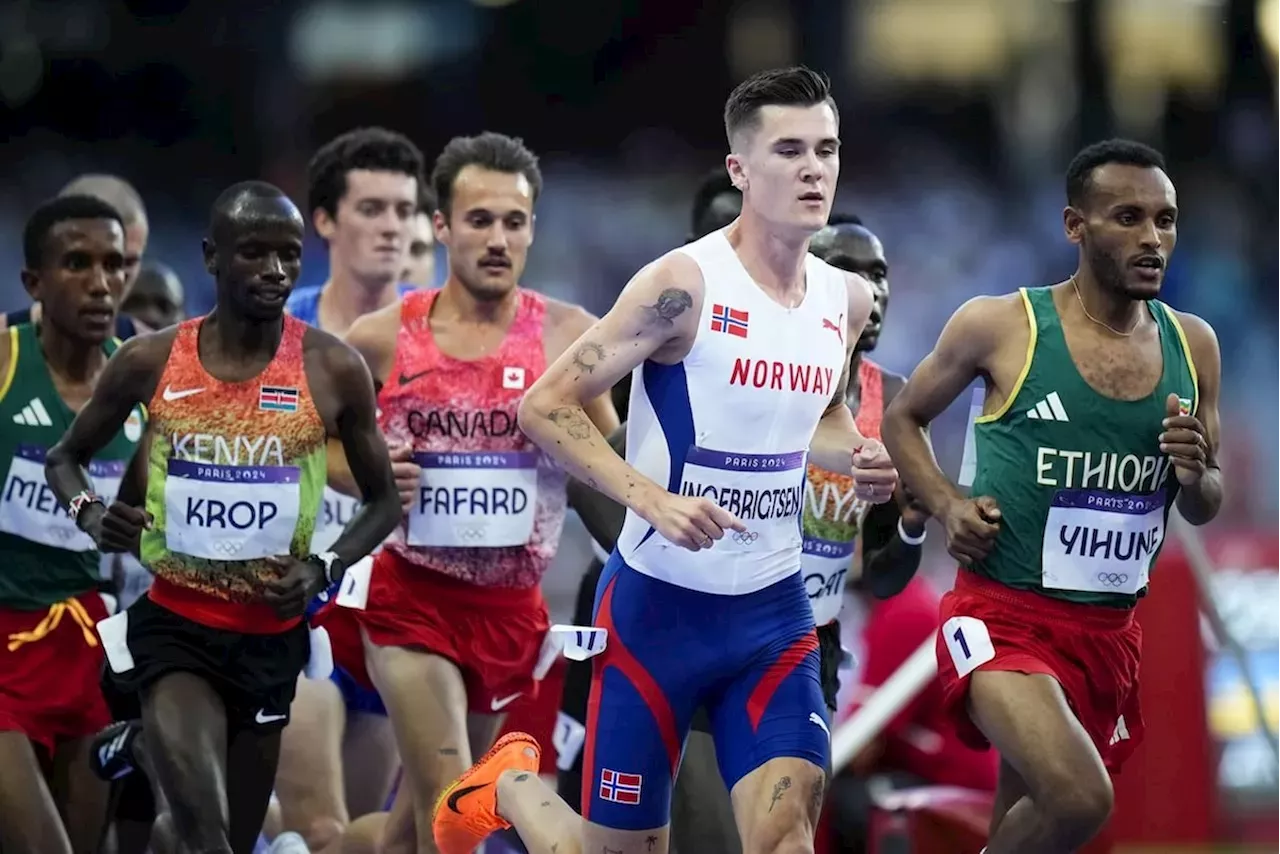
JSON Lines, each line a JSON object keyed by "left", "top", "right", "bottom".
{"left": 102, "top": 597, "right": 311, "bottom": 732}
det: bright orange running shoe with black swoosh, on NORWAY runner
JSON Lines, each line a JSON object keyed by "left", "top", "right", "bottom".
{"left": 431, "top": 732, "right": 543, "bottom": 854}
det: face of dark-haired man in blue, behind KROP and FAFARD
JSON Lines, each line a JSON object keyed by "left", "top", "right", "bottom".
{"left": 315, "top": 169, "right": 417, "bottom": 287}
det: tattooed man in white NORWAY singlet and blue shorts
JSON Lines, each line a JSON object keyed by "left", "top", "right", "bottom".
{"left": 435, "top": 68, "right": 897, "bottom": 854}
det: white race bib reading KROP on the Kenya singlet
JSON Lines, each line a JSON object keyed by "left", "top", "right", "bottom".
{"left": 164, "top": 460, "right": 301, "bottom": 561}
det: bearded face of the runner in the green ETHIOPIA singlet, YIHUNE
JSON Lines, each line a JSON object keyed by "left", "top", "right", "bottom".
{"left": 1062, "top": 163, "right": 1178, "bottom": 300}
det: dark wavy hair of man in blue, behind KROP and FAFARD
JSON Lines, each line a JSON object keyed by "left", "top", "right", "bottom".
{"left": 307, "top": 128, "right": 424, "bottom": 216}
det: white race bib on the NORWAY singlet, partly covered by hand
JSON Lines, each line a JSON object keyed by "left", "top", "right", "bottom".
{"left": 680, "top": 447, "right": 806, "bottom": 554}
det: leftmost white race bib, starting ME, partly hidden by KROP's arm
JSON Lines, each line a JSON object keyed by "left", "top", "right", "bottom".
{"left": 0, "top": 444, "right": 125, "bottom": 552}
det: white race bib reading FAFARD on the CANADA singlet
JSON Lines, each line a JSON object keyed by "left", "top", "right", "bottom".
{"left": 407, "top": 451, "right": 538, "bottom": 548}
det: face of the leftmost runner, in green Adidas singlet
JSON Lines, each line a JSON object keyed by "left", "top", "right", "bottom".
{"left": 22, "top": 219, "right": 125, "bottom": 344}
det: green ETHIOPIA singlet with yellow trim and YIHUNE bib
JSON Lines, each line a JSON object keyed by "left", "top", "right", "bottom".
{"left": 972, "top": 288, "right": 1199, "bottom": 608}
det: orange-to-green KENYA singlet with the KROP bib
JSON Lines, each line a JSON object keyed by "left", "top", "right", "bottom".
{"left": 141, "top": 316, "right": 328, "bottom": 631}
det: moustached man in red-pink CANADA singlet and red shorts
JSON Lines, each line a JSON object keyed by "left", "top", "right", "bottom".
{"left": 322, "top": 133, "right": 617, "bottom": 854}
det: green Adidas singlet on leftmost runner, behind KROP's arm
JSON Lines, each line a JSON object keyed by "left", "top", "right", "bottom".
{"left": 0, "top": 324, "right": 146, "bottom": 611}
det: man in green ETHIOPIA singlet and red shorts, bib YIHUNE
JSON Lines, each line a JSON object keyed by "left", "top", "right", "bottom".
{"left": 883, "top": 140, "right": 1222, "bottom": 854}
